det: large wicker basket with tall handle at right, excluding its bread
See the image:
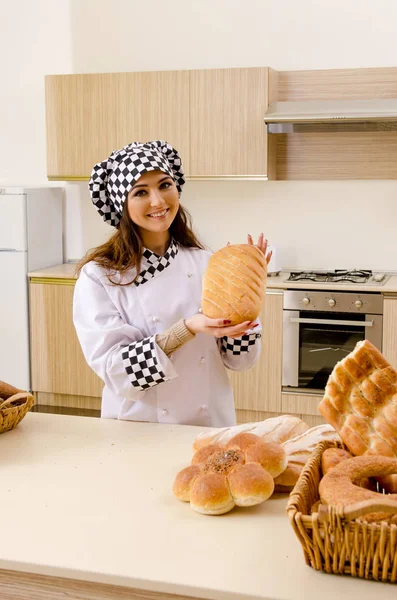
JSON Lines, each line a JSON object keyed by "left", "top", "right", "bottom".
{"left": 287, "top": 442, "right": 397, "bottom": 583}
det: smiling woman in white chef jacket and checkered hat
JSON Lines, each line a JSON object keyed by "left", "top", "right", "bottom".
{"left": 73, "top": 141, "right": 270, "bottom": 427}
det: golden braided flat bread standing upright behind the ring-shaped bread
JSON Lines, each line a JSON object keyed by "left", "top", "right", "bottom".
{"left": 319, "top": 340, "right": 397, "bottom": 457}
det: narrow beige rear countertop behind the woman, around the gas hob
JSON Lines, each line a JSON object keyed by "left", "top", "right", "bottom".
{"left": 29, "top": 263, "right": 397, "bottom": 294}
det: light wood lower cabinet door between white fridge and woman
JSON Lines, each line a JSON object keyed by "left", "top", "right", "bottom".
{"left": 30, "top": 283, "right": 103, "bottom": 397}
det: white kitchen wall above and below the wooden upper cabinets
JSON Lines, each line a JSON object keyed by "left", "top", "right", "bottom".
{"left": 0, "top": 0, "right": 397, "bottom": 271}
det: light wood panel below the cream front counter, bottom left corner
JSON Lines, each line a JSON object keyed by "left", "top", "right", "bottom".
{"left": 0, "top": 569, "right": 202, "bottom": 600}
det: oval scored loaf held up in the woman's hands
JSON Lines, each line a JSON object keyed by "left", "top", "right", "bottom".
{"left": 201, "top": 244, "right": 267, "bottom": 325}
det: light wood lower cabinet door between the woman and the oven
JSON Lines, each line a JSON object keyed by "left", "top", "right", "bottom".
{"left": 229, "top": 292, "right": 283, "bottom": 414}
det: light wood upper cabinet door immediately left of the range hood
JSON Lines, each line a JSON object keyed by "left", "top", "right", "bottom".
{"left": 190, "top": 67, "right": 269, "bottom": 176}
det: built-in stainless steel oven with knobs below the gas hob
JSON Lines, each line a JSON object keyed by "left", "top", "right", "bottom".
{"left": 282, "top": 290, "right": 383, "bottom": 393}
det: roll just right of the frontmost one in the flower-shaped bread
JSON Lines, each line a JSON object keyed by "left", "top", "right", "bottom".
{"left": 228, "top": 463, "right": 274, "bottom": 506}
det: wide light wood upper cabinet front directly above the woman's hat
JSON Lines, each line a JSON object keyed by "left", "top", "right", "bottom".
{"left": 46, "top": 71, "right": 189, "bottom": 179}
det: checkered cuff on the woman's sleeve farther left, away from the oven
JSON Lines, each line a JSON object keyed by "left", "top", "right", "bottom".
{"left": 122, "top": 335, "right": 169, "bottom": 391}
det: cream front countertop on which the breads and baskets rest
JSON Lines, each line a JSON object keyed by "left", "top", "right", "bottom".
{"left": 0, "top": 413, "right": 397, "bottom": 600}
